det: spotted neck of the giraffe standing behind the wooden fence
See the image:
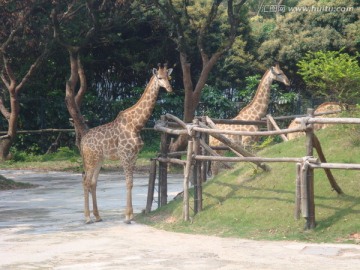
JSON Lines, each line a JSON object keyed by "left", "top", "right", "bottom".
{"left": 234, "top": 70, "right": 273, "bottom": 120}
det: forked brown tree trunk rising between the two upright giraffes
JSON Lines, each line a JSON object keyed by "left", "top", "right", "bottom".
{"left": 152, "top": 0, "right": 246, "bottom": 152}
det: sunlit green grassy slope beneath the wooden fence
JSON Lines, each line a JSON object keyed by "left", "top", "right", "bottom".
{"left": 138, "top": 123, "right": 360, "bottom": 242}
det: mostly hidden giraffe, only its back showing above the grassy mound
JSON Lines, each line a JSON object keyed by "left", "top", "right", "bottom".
{"left": 287, "top": 102, "right": 343, "bottom": 140}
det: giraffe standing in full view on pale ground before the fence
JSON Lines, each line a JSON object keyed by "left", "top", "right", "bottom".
{"left": 80, "top": 65, "right": 172, "bottom": 224}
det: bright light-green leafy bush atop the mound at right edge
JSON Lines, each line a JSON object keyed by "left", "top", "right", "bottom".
{"left": 297, "top": 51, "right": 360, "bottom": 104}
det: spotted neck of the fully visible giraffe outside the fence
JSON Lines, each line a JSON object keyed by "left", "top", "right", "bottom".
{"left": 115, "top": 76, "right": 160, "bottom": 132}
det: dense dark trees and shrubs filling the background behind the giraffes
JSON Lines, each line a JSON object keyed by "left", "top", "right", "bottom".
{"left": 0, "top": 0, "right": 360, "bottom": 154}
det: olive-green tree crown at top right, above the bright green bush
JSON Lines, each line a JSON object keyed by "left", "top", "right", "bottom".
{"left": 258, "top": 0, "right": 360, "bottom": 68}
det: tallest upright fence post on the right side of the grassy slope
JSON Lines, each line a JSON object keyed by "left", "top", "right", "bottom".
{"left": 305, "top": 108, "right": 316, "bottom": 229}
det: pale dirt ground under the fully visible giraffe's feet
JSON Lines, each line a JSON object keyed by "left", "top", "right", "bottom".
{"left": 0, "top": 171, "right": 360, "bottom": 270}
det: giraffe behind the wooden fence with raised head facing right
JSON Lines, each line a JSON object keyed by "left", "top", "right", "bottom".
{"left": 209, "top": 64, "right": 290, "bottom": 175}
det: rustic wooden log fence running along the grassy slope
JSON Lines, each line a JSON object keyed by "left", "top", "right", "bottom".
{"left": 146, "top": 109, "right": 360, "bottom": 229}
